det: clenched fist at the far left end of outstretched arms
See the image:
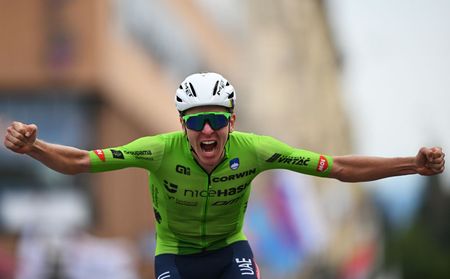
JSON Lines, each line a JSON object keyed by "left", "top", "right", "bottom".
{"left": 4, "top": 121, "right": 38, "bottom": 154}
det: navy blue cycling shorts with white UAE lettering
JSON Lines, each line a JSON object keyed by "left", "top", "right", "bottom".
{"left": 155, "top": 241, "right": 259, "bottom": 279}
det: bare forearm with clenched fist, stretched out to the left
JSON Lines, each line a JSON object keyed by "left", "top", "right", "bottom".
{"left": 4, "top": 122, "right": 90, "bottom": 174}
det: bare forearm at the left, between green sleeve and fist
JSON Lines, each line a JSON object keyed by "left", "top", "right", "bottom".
{"left": 27, "top": 140, "right": 90, "bottom": 174}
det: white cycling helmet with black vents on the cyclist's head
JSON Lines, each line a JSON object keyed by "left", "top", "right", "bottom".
{"left": 175, "top": 73, "right": 236, "bottom": 113}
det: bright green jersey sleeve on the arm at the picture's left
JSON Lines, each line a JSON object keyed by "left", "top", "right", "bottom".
{"left": 89, "top": 136, "right": 165, "bottom": 172}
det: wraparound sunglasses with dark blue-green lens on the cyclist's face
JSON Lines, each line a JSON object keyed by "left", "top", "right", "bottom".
{"left": 183, "top": 112, "right": 231, "bottom": 132}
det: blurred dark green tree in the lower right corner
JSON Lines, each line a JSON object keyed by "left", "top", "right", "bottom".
{"left": 386, "top": 176, "right": 450, "bottom": 279}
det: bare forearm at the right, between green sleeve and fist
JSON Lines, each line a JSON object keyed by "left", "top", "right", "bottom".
{"left": 330, "top": 156, "right": 417, "bottom": 182}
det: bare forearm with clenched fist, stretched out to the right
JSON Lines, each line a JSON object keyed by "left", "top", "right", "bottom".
{"left": 330, "top": 147, "right": 445, "bottom": 182}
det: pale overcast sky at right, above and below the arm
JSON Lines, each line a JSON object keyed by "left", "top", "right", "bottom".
{"left": 326, "top": 0, "right": 450, "bottom": 225}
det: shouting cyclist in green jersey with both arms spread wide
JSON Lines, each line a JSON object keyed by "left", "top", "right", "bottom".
{"left": 4, "top": 73, "right": 445, "bottom": 279}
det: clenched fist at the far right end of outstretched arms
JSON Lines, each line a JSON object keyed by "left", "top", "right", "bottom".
{"left": 415, "top": 147, "right": 445, "bottom": 175}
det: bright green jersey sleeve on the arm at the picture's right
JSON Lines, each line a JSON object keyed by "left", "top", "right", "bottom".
{"left": 256, "top": 136, "right": 333, "bottom": 177}
